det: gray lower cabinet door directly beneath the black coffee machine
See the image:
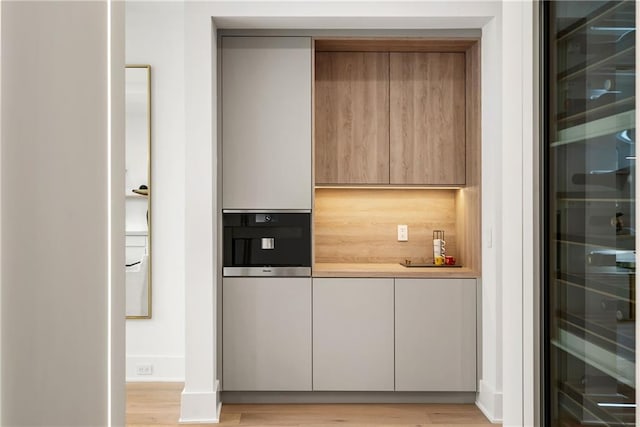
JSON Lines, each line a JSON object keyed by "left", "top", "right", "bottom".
{"left": 222, "top": 277, "right": 311, "bottom": 391}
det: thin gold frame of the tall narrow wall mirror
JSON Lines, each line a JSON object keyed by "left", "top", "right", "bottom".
{"left": 125, "top": 64, "right": 153, "bottom": 319}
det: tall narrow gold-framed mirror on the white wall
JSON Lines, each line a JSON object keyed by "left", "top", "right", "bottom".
{"left": 124, "top": 65, "right": 152, "bottom": 319}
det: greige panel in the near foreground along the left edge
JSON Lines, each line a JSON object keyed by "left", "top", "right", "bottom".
{"left": 0, "top": 1, "right": 124, "bottom": 426}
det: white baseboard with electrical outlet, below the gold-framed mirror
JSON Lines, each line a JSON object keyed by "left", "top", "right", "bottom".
{"left": 126, "top": 356, "right": 185, "bottom": 382}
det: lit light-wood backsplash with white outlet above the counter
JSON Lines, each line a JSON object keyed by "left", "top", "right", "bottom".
{"left": 314, "top": 188, "right": 459, "bottom": 263}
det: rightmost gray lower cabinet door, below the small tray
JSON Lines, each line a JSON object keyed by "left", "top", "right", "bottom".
{"left": 395, "top": 279, "right": 476, "bottom": 391}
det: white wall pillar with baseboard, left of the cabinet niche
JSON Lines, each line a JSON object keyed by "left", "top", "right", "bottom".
{"left": 180, "top": 2, "right": 221, "bottom": 422}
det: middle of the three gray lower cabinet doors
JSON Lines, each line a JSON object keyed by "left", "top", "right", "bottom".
{"left": 313, "top": 278, "right": 393, "bottom": 391}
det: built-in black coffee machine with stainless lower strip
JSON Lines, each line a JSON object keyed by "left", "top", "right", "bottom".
{"left": 222, "top": 210, "right": 311, "bottom": 277}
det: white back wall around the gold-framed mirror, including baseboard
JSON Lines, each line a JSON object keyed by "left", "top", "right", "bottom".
{"left": 125, "top": 1, "right": 185, "bottom": 381}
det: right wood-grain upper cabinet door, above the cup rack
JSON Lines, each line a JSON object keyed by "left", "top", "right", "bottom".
{"left": 389, "top": 52, "right": 466, "bottom": 185}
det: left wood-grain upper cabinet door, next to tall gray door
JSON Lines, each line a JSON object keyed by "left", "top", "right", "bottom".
{"left": 315, "top": 52, "right": 389, "bottom": 184}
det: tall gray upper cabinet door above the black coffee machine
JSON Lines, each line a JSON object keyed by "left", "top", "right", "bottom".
{"left": 221, "top": 36, "right": 311, "bottom": 209}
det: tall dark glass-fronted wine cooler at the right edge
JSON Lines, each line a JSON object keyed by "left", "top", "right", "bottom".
{"left": 541, "top": 1, "right": 637, "bottom": 427}
